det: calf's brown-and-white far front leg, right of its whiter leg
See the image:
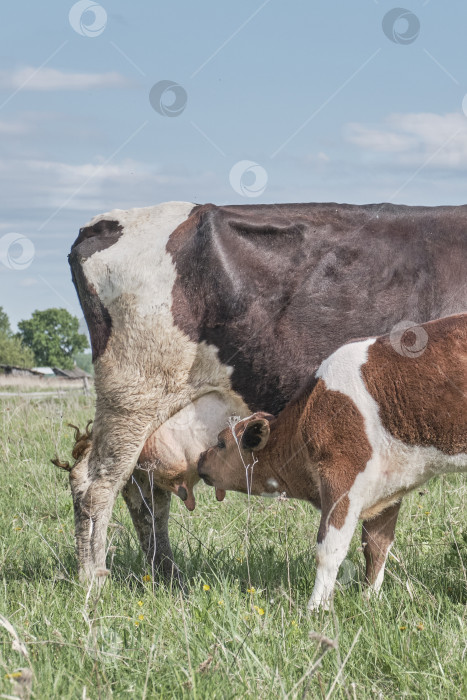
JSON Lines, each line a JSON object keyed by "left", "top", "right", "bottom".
{"left": 362, "top": 502, "right": 401, "bottom": 593}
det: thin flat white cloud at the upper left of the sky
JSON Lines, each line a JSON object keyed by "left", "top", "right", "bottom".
{"left": 0, "top": 66, "right": 133, "bottom": 92}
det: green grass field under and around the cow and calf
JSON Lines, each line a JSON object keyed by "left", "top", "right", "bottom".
{"left": 0, "top": 395, "right": 467, "bottom": 700}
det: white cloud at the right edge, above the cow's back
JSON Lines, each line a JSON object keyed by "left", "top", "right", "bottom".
{"left": 344, "top": 112, "right": 467, "bottom": 170}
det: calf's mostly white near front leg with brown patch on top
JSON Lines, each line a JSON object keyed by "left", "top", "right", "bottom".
{"left": 308, "top": 482, "right": 360, "bottom": 611}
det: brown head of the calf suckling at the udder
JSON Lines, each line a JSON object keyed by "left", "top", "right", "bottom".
{"left": 198, "top": 412, "right": 278, "bottom": 501}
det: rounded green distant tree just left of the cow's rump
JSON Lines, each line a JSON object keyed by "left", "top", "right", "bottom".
{"left": 18, "top": 309, "right": 88, "bottom": 369}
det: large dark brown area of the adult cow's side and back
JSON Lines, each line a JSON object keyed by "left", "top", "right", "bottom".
{"left": 169, "top": 204, "right": 467, "bottom": 413}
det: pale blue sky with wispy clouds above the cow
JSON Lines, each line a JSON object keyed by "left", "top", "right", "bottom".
{"left": 0, "top": 0, "right": 467, "bottom": 327}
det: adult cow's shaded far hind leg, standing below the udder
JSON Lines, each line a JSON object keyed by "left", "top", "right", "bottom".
{"left": 122, "top": 467, "right": 181, "bottom": 583}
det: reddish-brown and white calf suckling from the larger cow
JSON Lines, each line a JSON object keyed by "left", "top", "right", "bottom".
{"left": 198, "top": 314, "right": 467, "bottom": 610}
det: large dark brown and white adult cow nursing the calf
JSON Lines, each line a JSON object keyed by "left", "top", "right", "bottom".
{"left": 69, "top": 202, "right": 467, "bottom": 582}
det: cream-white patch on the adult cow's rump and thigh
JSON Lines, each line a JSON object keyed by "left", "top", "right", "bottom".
{"left": 79, "top": 202, "right": 249, "bottom": 446}
